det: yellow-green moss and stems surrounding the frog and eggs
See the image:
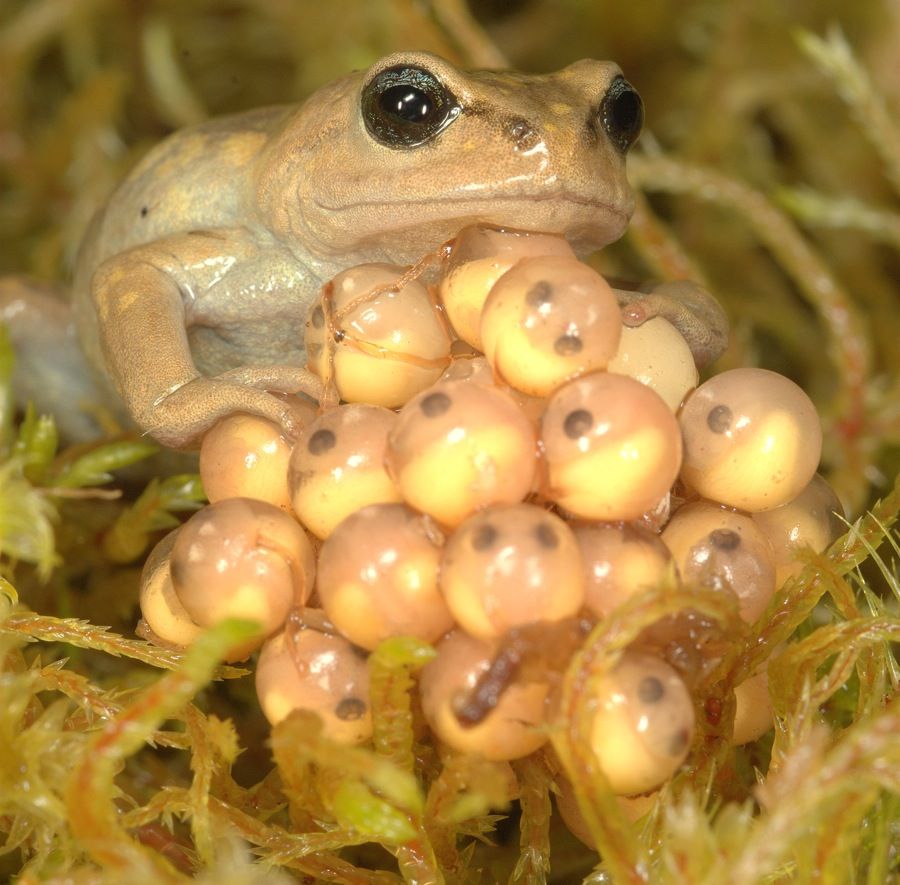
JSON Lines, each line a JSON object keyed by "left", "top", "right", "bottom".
{"left": 0, "top": 0, "right": 900, "bottom": 885}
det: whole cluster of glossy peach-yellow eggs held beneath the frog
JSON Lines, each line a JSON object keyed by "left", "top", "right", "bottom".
{"left": 141, "top": 227, "right": 838, "bottom": 812}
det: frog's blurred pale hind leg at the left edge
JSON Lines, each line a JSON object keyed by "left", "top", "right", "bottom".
{"left": 0, "top": 277, "right": 116, "bottom": 442}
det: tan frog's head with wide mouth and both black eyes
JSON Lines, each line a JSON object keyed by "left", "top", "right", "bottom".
{"left": 260, "top": 52, "right": 643, "bottom": 263}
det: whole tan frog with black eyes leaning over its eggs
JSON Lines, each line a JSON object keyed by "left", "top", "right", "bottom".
{"left": 0, "top": 51, "right": 727, "bottom": 449}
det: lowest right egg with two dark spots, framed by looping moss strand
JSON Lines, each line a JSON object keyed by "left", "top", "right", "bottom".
{"left": 588, "top": 651, "right": 694, "bottom": 795}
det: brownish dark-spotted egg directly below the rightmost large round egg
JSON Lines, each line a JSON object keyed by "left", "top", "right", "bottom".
{"left": 662, "top": 501, "right": 775, "bottom": 623}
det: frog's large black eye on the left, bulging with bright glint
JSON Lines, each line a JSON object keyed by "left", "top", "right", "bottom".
{"left": 362, "top": 65, "right": 460, "bottom": 148}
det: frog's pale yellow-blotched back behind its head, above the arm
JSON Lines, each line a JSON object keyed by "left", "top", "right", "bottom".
{"left": 75, "top": 107, "right": 291, "bottom": 280}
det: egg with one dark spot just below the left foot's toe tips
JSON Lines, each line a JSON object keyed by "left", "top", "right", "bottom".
{"left": 290, "top": 403, "right": 400, "bottom": 538}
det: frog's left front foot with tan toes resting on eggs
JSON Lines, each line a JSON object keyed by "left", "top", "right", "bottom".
{"left": 141, "top": 366, "right": 320, "bottom": 449}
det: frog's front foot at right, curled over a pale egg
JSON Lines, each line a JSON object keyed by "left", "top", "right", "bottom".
{"left": 615, "top": 280, "right": 728, "bottom": 369}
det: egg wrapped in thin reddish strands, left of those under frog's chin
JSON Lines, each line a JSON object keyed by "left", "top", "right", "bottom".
{"left": 306, "top": 264, "right": 450, "bottom": 409}
